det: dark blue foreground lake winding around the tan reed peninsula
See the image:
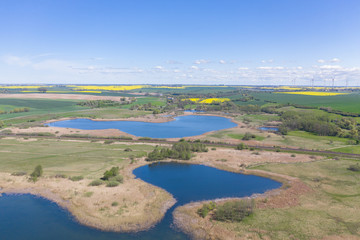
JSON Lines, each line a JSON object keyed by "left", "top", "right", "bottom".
{"left": 0, "top": 163, "right": 281, "bottom": 240}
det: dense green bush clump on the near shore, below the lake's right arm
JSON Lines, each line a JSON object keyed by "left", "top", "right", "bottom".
{"left": 213, "top": 199, "right": 254, "bottom": 222}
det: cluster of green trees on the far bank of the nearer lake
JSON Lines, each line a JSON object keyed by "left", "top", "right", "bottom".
{"left": 146, "top": 141, "right": 208, "bottom": 161}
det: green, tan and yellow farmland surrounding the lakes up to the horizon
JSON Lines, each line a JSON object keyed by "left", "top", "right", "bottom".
{"left": 0, "top": 85, "right": 360, "bottom": 239}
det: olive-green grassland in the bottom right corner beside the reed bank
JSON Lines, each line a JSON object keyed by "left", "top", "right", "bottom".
{"left": 219, "top": 160, "right": 360, "bottom": 239}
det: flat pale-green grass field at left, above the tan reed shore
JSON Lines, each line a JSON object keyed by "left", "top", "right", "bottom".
{"left": 0, "top": 139, "right": 153, "bottom": 178}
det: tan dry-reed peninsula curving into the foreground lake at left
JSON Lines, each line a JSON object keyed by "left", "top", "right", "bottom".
{"left": 0, "top": 159, "right": 176, "bottom": 233}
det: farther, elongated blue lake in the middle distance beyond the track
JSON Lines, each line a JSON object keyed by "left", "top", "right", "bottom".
{"left": 46, "top": 116, "right": 237, "bottom": 138}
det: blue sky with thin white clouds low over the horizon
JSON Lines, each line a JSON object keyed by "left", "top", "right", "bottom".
{"left": 0, "top": 0, "right": 360, "bottom": 86}
